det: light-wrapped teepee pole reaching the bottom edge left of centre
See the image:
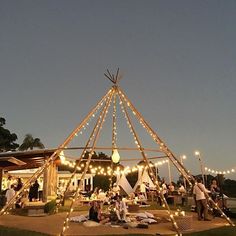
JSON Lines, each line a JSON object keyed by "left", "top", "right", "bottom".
{"left": 61, "top": 90, "right": 114, "bottom": 235}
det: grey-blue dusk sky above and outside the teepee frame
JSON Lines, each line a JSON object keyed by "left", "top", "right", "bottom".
{"left": 0, "top": 0, "right": 236, "bottom": 179}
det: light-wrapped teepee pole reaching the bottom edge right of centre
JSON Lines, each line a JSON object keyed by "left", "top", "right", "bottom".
{"left": 119, "top": 88, "right": 181, "bottom": 235}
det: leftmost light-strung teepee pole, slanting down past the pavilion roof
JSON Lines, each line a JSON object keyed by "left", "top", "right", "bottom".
{"left": 0, "top": 89, "right": 112, "bottom": 216}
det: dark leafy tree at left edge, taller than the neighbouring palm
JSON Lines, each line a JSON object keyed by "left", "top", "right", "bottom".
{"left": 0, "top": 117, "right": 19, "bottom": 152}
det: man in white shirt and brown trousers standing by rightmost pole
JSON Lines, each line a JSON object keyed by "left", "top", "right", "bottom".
{"left": 193, "top": 178, "right": 210, "bottom": 221}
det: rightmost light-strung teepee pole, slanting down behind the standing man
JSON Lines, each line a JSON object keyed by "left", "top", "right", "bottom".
{"left": 119, "top": 89, "right": 235, "bottom": 226}
